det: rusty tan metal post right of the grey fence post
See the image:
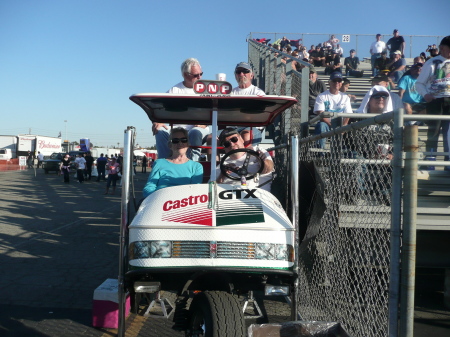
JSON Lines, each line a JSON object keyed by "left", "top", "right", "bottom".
{"left": 400, "top": 125, "right": 419, "bottom": 337}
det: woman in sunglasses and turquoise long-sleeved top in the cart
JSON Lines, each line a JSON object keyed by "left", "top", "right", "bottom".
{"left": 143, "top": 128, "right": 203, "bottom": 198}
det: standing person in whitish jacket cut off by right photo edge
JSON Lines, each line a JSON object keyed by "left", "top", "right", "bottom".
{"left": 416, "top": 35, "right": 450, "bottom": 170}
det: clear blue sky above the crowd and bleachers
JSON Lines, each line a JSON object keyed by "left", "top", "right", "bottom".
{"left": 0, "top": 0, "right": 450, "bottom": 146}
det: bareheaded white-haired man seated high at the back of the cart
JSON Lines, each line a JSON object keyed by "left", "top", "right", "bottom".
{"left": 152, "top": 58, "right": 210, "bottom": 161}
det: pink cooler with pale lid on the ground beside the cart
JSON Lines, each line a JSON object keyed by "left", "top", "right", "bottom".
{"left": 92, "top": 278, "right": 130, "bottom": 329}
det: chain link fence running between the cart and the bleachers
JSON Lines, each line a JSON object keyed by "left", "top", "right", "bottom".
{"left": 249, "top": 41, "right": 397, "bottom": 337}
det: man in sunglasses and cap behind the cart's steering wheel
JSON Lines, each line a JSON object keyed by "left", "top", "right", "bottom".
{"left": 216, "top": 128, "right": 274, "bottom": 191}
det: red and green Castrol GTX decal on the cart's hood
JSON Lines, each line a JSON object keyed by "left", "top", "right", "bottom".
{"left": 161, "top": 189, "right": 264, "bottom": 226}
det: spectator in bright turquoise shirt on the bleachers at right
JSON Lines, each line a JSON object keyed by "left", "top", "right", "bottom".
{"left": 398, "top": 63, "right": 426, "bottom": 118}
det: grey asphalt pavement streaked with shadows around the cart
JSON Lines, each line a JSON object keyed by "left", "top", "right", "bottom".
{"left": 0, "top": 170, "right": 450, "bottom": 337}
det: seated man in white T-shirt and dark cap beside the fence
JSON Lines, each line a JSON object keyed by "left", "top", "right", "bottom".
{"left": 314, "top": 71, "right": 353, "bottom": 149}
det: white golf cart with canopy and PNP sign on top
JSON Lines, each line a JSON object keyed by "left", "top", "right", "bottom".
{"left": 119, "top": 80, "right": 298, "bottom": 336}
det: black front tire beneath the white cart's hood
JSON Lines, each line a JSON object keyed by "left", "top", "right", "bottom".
{"left": 186, "top": 291, "right": 247, "bottom": 337}
